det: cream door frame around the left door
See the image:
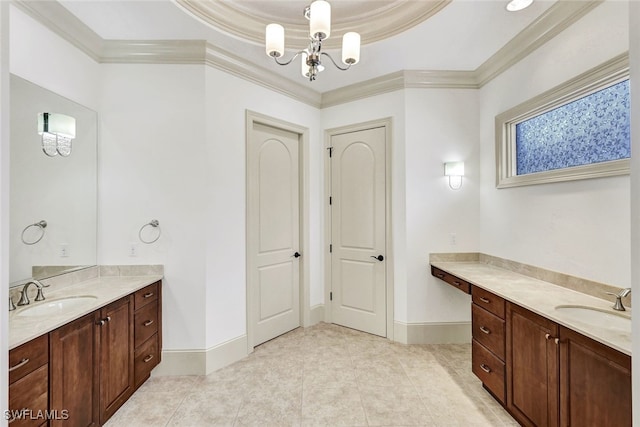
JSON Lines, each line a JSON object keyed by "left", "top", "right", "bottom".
{"left": 245, "top": 110, "right": 311, "bottom": 353}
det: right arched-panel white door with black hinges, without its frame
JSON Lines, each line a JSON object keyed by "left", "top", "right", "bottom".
{"left": 331, "top": 127, "right": 387, "bottom": 337}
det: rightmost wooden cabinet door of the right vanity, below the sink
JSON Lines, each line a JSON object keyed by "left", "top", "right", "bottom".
{"left": 560, "top": 327, "right": 631, "bottom": 427}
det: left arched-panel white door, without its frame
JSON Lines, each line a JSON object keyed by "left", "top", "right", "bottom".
{"left": 247, "top": 122, "right": 300, "bottom": 346}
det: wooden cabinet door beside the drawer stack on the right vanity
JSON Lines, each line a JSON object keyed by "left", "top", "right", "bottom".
{"left": 506, "top": 303, "right": 558, "bottom": 427}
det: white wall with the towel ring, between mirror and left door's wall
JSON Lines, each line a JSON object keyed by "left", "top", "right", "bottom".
{"left": 98, "top": 64, "right": 211, "bottom": 349}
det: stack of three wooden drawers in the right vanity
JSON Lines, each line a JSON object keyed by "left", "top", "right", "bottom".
{"left": 471, "top": 286, "right": 505, "bottom": 404}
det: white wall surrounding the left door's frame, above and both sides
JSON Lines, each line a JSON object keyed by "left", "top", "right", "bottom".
{"left": 201, "top": 68, "right": 324, "bottom": 347}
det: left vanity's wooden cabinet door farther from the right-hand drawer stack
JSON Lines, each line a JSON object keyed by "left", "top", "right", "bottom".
{"left": 49, "top": 312, "right": 99, "bottom": 427}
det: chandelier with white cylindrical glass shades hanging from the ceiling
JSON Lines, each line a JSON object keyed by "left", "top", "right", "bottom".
{"left": 265, "top": 0, "right": 360, "bottom": 81}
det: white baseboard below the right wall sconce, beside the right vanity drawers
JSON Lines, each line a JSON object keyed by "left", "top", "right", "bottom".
{"left": 393, "top": 321, "right": 471, "bottom": 344}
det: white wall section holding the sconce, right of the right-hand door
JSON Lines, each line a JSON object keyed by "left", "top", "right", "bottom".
{"left": 405, "top": 89, "right": 480, "bottom": 323}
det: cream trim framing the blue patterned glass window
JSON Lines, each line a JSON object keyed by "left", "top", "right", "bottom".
{"left": 495, "top": 52, "right": 631, "bottom": 188}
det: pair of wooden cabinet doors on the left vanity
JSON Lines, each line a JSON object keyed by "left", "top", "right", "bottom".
{"left": 50, "top": 295, "right": 134, "bottom": 426}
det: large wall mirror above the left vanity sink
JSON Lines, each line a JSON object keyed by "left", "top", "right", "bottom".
{"left": 9, "top": 75, "right": 98, "bottom": 286}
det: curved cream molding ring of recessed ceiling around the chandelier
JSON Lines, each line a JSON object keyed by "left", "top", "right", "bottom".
{"left": 174, "top": 0, "right": 452, "bottom": 49}
